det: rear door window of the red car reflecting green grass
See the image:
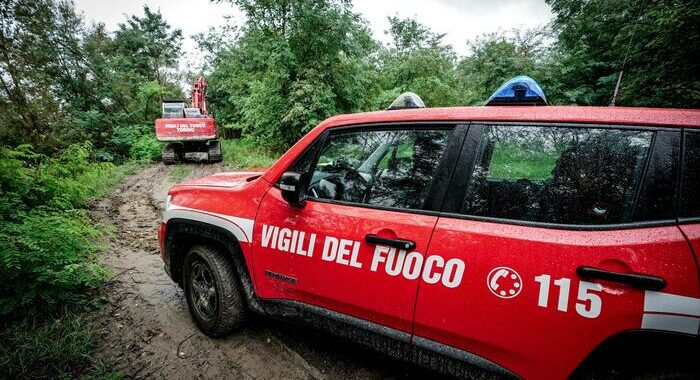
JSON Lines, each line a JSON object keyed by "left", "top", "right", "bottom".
{"left": 462, "top": 125, "right": 653, "bottom": 225}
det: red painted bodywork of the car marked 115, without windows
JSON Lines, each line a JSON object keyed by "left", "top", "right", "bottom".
{"left": 159, "top": 107, "right": 700, "bottom": 379}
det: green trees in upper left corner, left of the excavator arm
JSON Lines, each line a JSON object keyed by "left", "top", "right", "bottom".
{"left": 0, "top": 0, "right": 183, "bottom": 161}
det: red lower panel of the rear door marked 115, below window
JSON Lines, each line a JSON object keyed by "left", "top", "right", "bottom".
{"left": 414, "top": 218, "right": 700, "bottom": 379}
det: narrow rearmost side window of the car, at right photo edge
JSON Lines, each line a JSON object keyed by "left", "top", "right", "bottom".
{"left": 680, "top": 132, "right": 700, "bottom": 217}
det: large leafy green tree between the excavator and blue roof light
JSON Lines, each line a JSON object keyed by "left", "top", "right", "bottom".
{"left": 205, "top": 0, "right": 376, "bottom": 147}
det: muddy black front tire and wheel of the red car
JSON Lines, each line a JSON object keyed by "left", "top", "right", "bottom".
{"left": 183, "top": 245, "right": 247, "bottom": 337}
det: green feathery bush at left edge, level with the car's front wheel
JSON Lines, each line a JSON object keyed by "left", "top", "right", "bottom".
{"left": 0, "top": 210, "right": 107, "bottom": 317}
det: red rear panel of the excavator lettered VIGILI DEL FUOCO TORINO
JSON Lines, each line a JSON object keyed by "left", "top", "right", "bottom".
{"left": 156, "top": 117, "right": 216, "bottom": 141}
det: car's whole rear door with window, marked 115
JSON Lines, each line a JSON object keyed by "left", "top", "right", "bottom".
{"left": 414, "top": 123, "right": 698, "bottom": 378}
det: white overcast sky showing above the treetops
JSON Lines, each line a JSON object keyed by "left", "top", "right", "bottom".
{"left": 74, "top": 0, "right": 552, "bottom": 55}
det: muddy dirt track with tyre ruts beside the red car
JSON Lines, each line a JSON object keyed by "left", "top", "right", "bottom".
{"left": 93, "top": 164, "right": 436, "bottom": 379}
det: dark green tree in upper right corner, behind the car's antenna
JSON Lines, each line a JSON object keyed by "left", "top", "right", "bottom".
{"left": 547, "top": 0, "right": 700, "bottom": 108}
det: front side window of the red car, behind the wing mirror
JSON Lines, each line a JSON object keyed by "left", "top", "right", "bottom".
{"left": 308, "top": 129, "right": 451, "bottom": 209}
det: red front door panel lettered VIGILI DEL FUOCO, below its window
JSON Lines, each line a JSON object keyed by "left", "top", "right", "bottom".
{"left": 253, "top": 188, "right": 437, "bottom": 333}
